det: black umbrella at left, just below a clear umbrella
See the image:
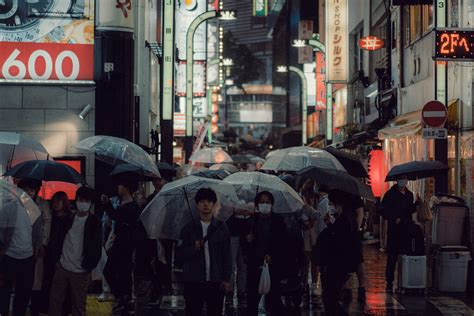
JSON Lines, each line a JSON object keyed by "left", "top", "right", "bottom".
{"left": 4, "top": 160, "right": 86, "bottom": 184}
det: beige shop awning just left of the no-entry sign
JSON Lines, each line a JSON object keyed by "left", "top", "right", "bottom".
{"left": 378, "top": 110, "right": 422, "bottom": 140}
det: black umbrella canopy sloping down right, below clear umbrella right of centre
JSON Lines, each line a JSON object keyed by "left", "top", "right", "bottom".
{"left": 296, "top": 167, "right": 375, "bottom": 200}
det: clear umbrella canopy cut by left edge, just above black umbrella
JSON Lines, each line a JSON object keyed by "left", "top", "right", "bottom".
{"left": 0, "top": 132, "right": 50, "bottom": 172}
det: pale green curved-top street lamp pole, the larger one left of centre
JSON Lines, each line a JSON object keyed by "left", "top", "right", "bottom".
{"left": 185, "top": 10, "right": 217, "bottom": 162}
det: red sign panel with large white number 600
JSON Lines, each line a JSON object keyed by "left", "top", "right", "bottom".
{"left": 0, "top": 42, "right": 94, "bottom": 81}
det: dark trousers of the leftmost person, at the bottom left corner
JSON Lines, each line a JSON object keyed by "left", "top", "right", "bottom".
{"left": 0, "top": 255, "right": 35, "bottom": 316}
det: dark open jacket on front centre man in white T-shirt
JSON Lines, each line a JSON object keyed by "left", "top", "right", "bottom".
{"left": 175, "top": 218, "right": 232, "bottom": 283}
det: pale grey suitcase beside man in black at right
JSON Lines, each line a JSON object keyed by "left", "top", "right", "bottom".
{"left": 398, "top": 255, "right": 427, "bottom": 294}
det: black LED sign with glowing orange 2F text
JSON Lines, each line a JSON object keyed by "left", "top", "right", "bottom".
{"left": 434, "top": 28, "right": 474, "bottom": 60}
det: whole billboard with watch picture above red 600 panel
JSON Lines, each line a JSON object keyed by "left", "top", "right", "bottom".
{"left": 0, "top": 0, "right": 94, "bottom": 83}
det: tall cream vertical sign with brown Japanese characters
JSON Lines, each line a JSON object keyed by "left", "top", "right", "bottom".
{"left": 326, "top": 0, "right": 348, "bottom": 83}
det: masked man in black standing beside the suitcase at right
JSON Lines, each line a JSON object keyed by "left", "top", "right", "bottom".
{"left": 381, "top": 176, "right": 419, "bottom": 293}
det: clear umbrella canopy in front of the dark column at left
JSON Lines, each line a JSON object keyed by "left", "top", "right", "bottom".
{"left": 74, "top": 135, "right": 160, "bottom": 176}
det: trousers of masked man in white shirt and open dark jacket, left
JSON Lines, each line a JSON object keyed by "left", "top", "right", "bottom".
{"left": 48, "top": 264, "right": 90, "bottom": 316}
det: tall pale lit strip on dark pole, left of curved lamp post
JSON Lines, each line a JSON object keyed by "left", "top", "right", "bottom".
{"left": 162, "top": 0, "right": 175, "bottom": 120}
